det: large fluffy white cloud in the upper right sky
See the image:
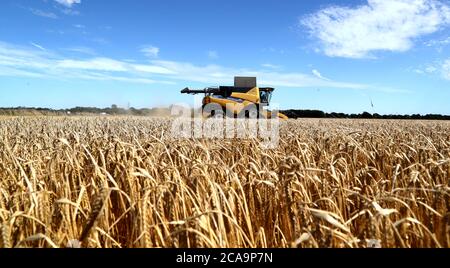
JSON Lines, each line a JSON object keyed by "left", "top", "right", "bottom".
{"left": 300, "top": 0, "right": 450, "bottom": 58}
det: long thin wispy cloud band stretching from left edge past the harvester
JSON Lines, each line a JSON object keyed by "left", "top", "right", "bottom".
{"left": 0, "top": 39, "right": 394, "bottom": 90}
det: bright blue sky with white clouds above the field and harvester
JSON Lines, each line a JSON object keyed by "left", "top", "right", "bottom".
{"left": 0, "top": 0, "right": 450, "bottom": 114}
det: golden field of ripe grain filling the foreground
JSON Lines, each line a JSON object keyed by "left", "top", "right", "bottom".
{"left": 0, "top": 116, "right": 450, "bottom": 248}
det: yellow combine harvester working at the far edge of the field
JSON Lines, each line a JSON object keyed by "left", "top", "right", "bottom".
{"left": 181, "top": 77, "right": 288, "bottom": 119}
